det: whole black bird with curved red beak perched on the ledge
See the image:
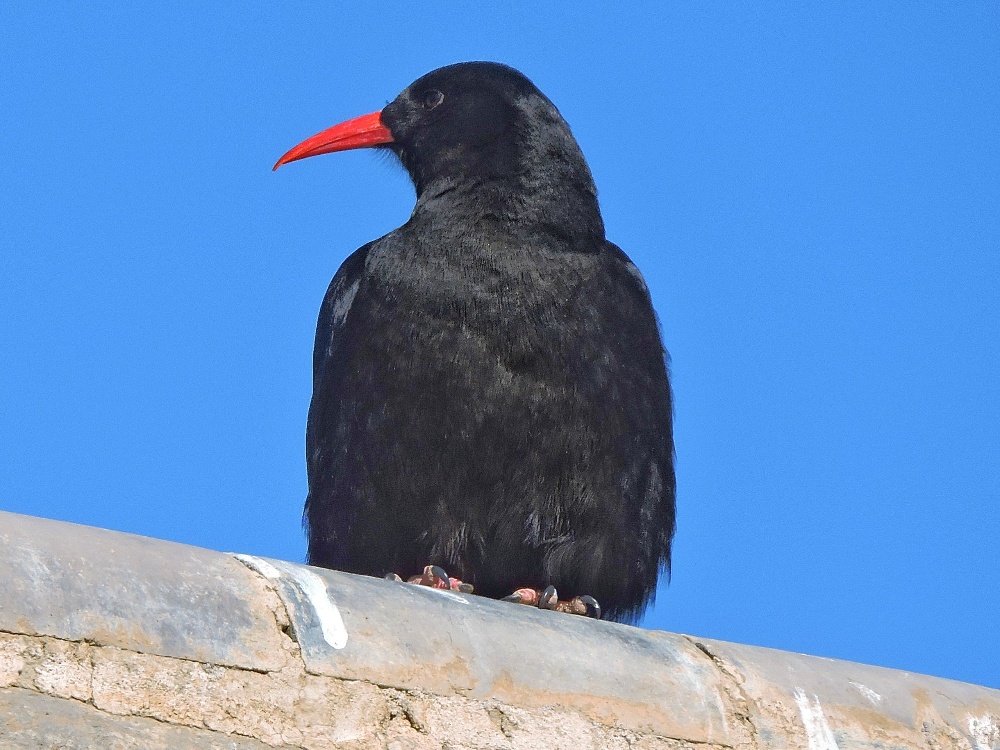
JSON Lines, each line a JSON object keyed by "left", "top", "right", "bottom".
{"left": 275, "top": 62, "right": 674, "bottom": 621}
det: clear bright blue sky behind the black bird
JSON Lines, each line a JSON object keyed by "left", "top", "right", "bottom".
{"left": 0, "top": 1, "right": 1000, "bottom": 687}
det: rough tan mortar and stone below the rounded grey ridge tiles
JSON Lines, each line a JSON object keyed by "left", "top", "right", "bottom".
{"left": 0, "top": 633, "right": 704, "bottom": 750}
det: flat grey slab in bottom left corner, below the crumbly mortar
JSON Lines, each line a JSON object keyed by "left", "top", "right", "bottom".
{"left": 0, "top": 688, "right": 286, "bottom": 750}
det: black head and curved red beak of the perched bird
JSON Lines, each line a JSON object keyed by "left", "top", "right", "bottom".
{"left": 274, "top": 62, "right": 596, "bottom": 203}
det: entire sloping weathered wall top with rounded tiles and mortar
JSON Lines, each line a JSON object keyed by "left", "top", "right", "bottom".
{"left": 0, "top": 513, "right": 1000, "bottom": 750}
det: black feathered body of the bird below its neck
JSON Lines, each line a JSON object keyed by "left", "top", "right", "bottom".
{"left": 307, "top": 220, "right": 674, "bottom": 619}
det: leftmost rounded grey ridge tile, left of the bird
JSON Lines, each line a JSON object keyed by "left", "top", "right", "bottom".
{"left": 0, "top": 511, "right": 280, "bottom": 669}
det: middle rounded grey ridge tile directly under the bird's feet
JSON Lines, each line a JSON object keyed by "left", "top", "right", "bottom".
{"left": 249, "top": 560, "right": 734, "bottom": 744}
